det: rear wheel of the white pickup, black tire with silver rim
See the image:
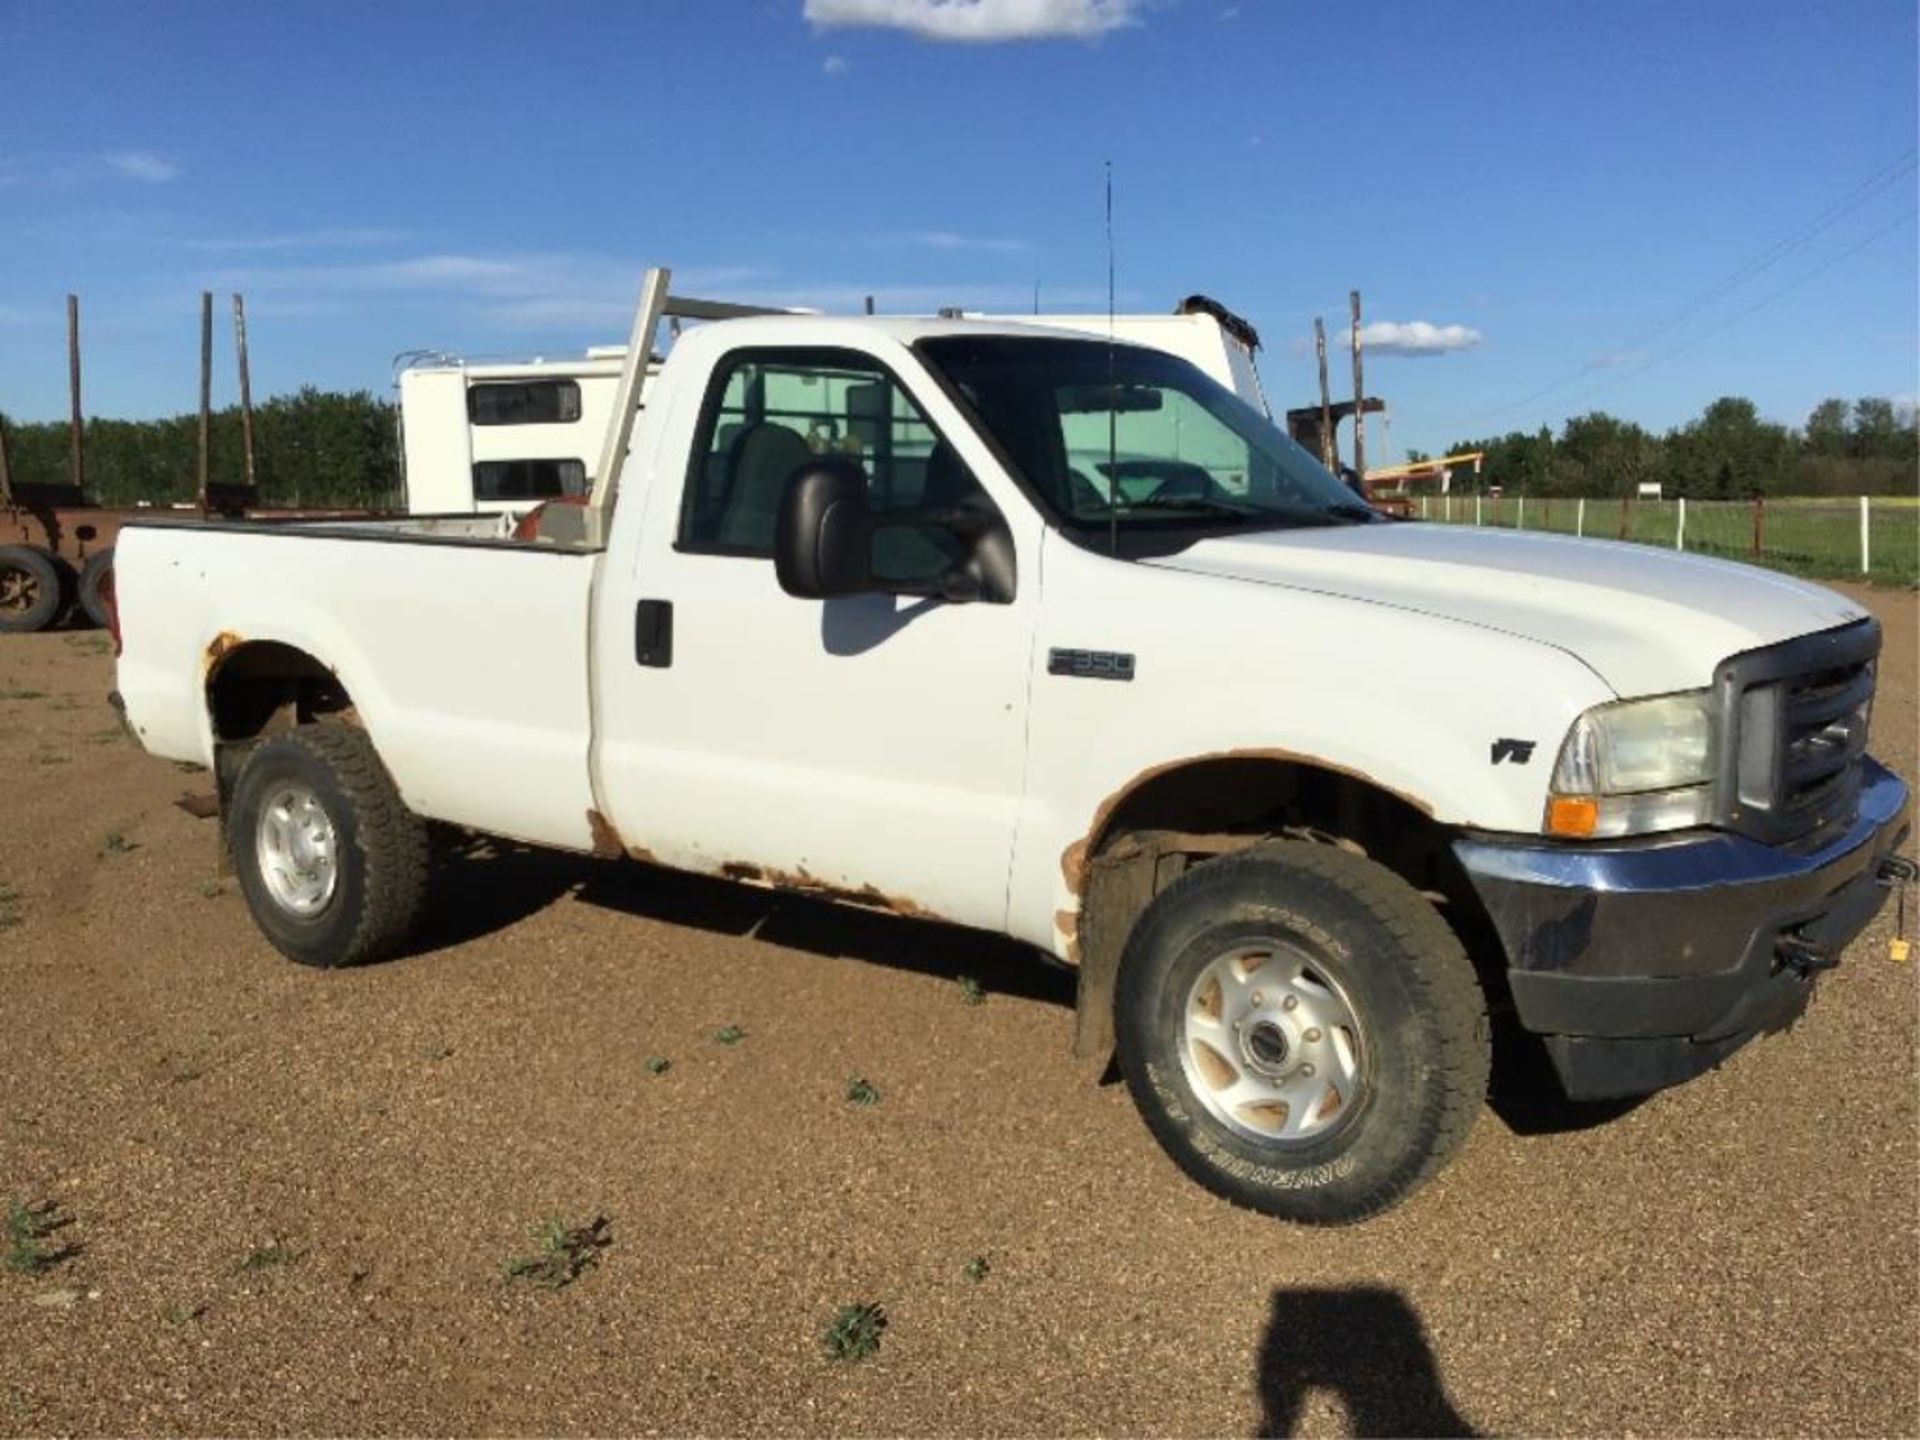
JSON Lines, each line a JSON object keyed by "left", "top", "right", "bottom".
{"left": 227, "top": 726, "right": 426, "bottom": 968}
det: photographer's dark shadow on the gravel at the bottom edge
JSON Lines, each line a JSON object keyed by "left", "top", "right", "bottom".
{"left": 1258, "top": 1286, "right": 1478, "bottom": 1436}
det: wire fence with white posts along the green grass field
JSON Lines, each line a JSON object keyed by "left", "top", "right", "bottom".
{"left": 1413, "top": 493, "right": 1920, "bottom": 586}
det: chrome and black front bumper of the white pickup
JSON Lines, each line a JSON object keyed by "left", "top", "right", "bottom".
{"left": 1453, "top": 758, "right": 1908, "bottom": 1100}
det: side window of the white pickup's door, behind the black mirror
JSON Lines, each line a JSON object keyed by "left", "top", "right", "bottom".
{"left": 680, "top": 351, "right": 981, "bottom": 580}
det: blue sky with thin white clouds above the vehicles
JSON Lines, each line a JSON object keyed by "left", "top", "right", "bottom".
{"left": 0, "top": 0, "right": 1920, "bottom": 463}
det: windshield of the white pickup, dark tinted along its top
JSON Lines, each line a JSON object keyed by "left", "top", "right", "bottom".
{"left": 920, "top": 336, "right": 1379, "bottom": 545}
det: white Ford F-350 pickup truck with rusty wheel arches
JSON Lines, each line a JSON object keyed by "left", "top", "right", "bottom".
{"left": 115, "top": 271, "right": 1910, "bottom": 1223}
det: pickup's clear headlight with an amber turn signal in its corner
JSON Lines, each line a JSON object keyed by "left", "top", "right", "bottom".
{"left": 1546, "top": 689, "right": 1715, "bottom": 839}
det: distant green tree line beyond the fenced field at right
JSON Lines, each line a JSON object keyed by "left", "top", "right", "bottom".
{"left": 1407, "top": 396, "right": 1920, "bottom": 499}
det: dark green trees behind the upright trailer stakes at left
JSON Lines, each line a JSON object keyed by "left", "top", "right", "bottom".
{"left": 0, "top": 386, "right": 403, "bottom": 507}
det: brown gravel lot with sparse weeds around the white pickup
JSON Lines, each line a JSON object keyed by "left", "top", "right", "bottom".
{"left": 0, "top": 591, "right": 1920, "bottom": 1434}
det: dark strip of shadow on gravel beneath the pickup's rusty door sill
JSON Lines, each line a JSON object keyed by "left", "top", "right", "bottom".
{"left": 574, "top": 862, "right": 1073, "bottom": 1010}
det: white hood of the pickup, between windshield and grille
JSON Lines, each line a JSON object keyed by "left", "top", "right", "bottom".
{"left": 1146, "top": 524, "right": 1866, "bottom": 697}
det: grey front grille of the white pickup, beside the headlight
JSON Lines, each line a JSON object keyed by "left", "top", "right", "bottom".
{"left": 1715, "top": 620, "right": 1880, "bottom": 845}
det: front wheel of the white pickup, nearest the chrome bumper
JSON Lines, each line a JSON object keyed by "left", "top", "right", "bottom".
{"left": 1114, "top": 841, "right": 1490, "bottom": 1225}
